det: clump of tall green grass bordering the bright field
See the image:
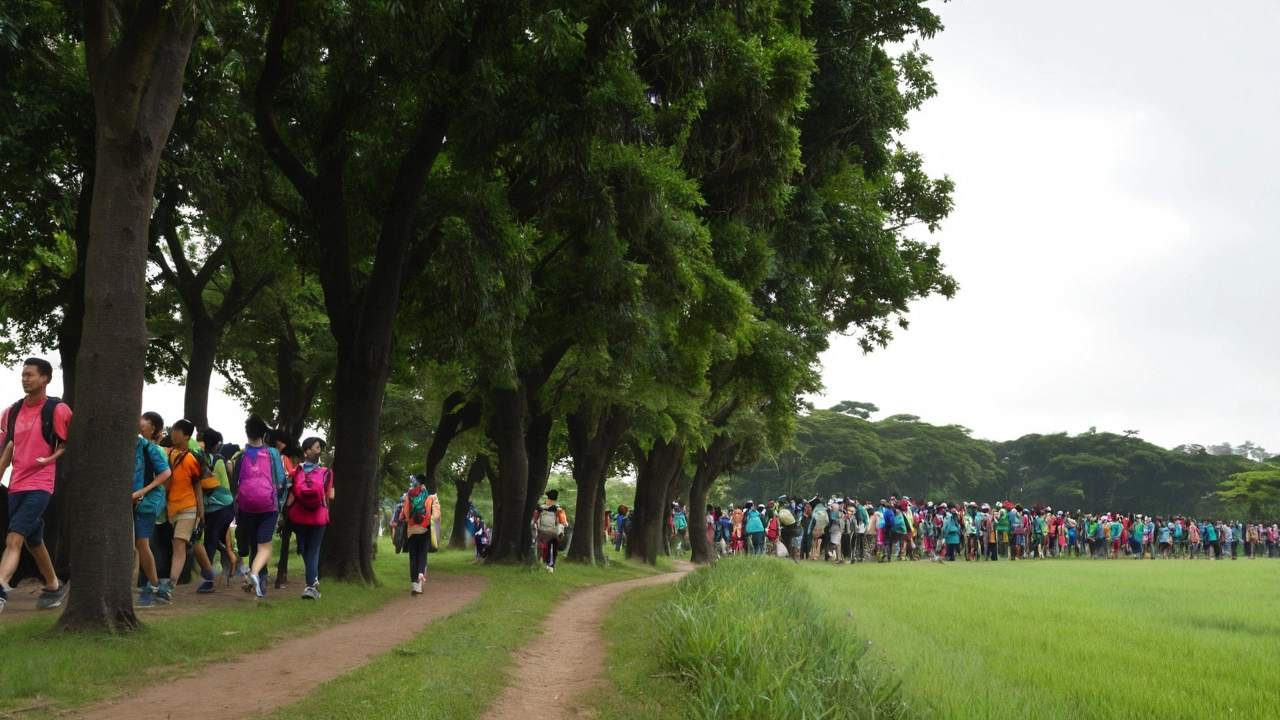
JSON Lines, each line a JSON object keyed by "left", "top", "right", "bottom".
{"left": 655, "top": 557, "right": 908, "bottom": 720}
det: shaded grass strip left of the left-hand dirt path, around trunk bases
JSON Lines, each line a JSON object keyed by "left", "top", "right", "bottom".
{"left": 0, "top": 541, "right": 442, "bottom": 712}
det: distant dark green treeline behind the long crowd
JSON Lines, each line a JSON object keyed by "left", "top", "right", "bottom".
{"left": 726, "top": 402, "right": 1280, "bottom": 520}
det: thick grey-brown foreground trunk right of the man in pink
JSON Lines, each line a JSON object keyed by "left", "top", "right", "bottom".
{"left": 58, "top": 0, "right": 196, "bottom": 632}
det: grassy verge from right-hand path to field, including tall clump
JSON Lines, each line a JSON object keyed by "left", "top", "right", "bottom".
{"left": 595, "top": 559, "right": 908, "bottom": 720}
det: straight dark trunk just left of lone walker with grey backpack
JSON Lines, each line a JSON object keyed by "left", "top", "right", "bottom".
{"left": 488, "top": 387, "right": 532, "bottom": 562}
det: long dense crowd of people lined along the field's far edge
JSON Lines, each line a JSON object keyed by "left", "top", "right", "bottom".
{"left": 701, "top": 495, "right": 1280, "bottom": 562}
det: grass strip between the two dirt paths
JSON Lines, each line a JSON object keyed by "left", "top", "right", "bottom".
{"left": 271, "top": 545, "right": 670, "bottom": 720}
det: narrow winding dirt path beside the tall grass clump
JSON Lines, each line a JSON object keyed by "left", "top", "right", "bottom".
{"left": 484, "top": 562, "right": 692, "bottom": 720}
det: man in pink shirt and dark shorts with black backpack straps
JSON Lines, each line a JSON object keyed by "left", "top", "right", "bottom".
{"left": 0, "top": 357, "right": 72, "bottom": 611}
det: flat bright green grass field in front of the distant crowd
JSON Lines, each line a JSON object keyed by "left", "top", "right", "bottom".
{"left": 803, "top": 560, "right": 1280, "bottom": 720}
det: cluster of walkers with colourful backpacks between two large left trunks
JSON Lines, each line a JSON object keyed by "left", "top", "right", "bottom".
{"left": 133, "top": 413, "right": 334, "bottom": 599}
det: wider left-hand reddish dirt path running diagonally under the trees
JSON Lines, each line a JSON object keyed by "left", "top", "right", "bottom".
{"left": 73, "top": 575, "right": 488, "bottom": 720}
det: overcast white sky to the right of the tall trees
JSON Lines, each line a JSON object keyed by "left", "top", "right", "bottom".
{"left": 812, "top": 0, "right": 1280, "bottom": 450}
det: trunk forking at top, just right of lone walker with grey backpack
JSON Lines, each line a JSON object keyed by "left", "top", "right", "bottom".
{"left": 564, "top": 404, "right": 631, "bottom": 562}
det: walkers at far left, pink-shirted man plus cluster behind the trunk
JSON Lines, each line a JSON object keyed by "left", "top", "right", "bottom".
{"left": 0, "top": 357, "right": 334, "bottom": 611}
